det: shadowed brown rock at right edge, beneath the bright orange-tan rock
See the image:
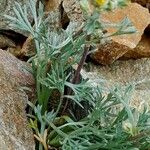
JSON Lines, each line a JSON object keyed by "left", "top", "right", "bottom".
{"left": 120, "top": 34, "right": 150, "bottom": 59}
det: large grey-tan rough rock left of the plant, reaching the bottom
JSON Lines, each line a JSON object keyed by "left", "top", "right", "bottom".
{"left": 0, "top": 50, "right": 35, "bottom": 150}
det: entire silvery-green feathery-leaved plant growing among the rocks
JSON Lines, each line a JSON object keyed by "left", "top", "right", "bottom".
{"left": 5, "top": 0, "right": 150, "bottom": 150}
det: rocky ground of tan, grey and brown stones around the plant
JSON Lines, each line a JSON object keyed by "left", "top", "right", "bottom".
{"left": 0, "top": 0, "right": 150, "bottom": 150}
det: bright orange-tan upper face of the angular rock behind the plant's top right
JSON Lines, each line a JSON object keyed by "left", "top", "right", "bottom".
{"left": 102, "top": 3, "right": 150, "bottom": 48}
